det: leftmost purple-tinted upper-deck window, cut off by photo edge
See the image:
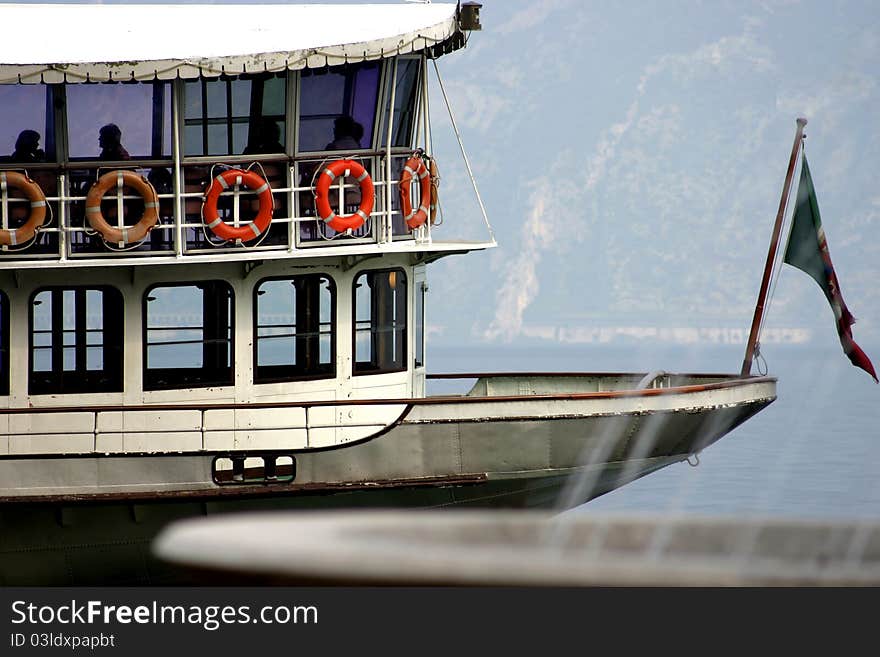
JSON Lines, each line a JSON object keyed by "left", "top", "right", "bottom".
{"left": 0, "top": 84, "right": 55, "bottom": 164}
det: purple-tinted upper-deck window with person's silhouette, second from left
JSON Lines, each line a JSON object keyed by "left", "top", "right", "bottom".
{"left": 65, "top": 82, "right": 171, "bottom": 161}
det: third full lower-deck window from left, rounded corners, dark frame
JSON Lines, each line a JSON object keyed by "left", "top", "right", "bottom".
{"left": 254, "top": 274, "right": 336, "bottom": 383}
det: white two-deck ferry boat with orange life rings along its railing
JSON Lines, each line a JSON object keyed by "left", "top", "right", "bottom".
{"left": 0, "top": 3, "right": 776, "bottom": 585}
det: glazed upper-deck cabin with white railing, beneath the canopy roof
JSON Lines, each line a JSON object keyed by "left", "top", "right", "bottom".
{"left": 0, "top": 28, "right": 464, "bottom": 258}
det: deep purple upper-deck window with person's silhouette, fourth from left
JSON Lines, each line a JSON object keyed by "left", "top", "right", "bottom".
{"left": 297, "top": 62, "right": 381, "bottom": 153}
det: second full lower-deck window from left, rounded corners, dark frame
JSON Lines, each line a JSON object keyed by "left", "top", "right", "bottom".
{"left": 144, "top": 281, "right": 234, "bottom": 390}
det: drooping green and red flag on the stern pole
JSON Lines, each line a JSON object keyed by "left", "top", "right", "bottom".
{"left": 784, "top": 155, "right": 880, "bottom": 383}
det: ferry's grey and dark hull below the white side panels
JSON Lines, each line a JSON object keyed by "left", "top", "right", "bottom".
{"left": 0, "top": 377, "right": 775, "bottom": 586}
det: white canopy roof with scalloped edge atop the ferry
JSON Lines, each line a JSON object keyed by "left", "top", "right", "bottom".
{"left": 0, "top": 3, "right": 457, "bottom": 84}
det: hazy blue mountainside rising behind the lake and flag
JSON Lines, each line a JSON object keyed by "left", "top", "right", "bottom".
{"left": 422, "top": 1, "right": 880, "bottom": 341}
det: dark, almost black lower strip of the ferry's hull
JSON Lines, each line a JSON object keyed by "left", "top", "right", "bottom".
{"left": 0, "top": 457, "right": 712, "bottom": 586}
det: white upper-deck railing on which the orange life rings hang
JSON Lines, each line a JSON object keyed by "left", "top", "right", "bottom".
{"left": 0, "top": 154, "right": 431, "bottom": 268}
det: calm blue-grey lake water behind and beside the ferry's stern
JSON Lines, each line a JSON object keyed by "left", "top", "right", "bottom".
{"left": 428, "top": 344, "right": 880, "bottom": 519}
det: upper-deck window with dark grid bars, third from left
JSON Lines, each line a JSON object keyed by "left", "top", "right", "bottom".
{"left": 183, "top": 75, "right": 287, "bottom": 156}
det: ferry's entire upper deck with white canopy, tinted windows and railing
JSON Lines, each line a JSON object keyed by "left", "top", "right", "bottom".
{"left": 0, "top": 4, "right": 485, "bottom": 269}
